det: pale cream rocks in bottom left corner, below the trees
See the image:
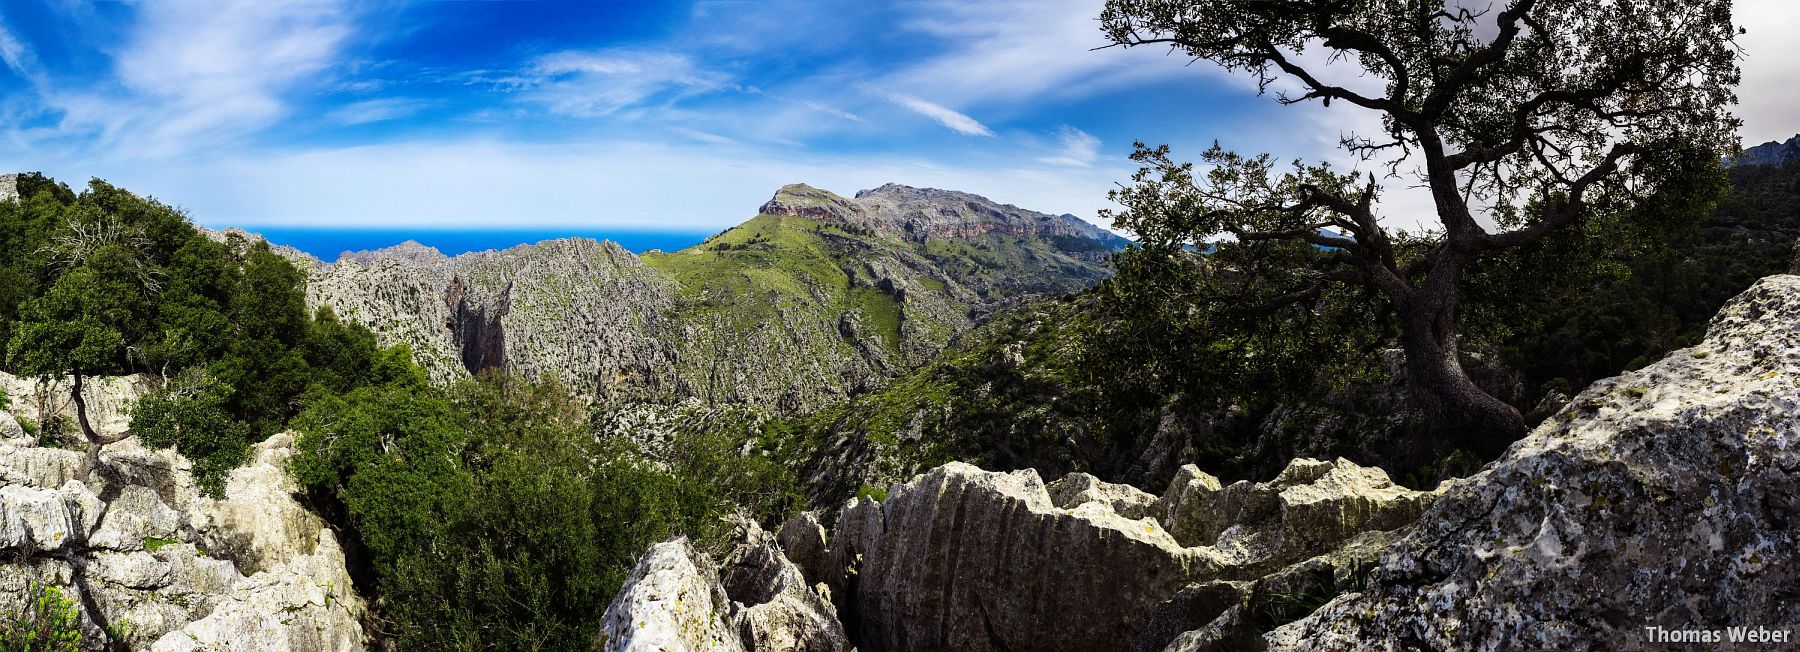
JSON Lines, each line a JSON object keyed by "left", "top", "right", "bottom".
{"left": 0, "top": 375, "right": 364, "bottom": 650}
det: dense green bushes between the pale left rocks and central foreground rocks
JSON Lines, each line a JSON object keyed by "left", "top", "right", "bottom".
{"left": 292, "top": 369, "right": 797, "bottom": 650}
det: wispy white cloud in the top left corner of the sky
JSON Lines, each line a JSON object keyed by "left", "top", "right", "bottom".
{"left": 0, "top": 2, "right": 353, "bottom": 158}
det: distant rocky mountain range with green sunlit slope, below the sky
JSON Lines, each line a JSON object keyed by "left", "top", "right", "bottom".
{"left": 291, "top": 184, "right": 1123, "bottom": 411}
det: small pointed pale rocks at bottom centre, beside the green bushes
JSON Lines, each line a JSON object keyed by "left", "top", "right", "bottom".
{"left": 598, "top": 521, "right": 850, "bottom": 652}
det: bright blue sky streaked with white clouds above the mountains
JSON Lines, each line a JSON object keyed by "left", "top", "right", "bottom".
{"left": 0, "top": 0, "right": 1800, "bottom": 229}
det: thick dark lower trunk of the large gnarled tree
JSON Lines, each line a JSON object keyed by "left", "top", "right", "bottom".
{"left": 1397, "top": 263, "right": 1525, "bottom": 459}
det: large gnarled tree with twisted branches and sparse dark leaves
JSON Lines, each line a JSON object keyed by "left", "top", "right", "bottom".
{"left": 1102, "top": 0, "right": 1739, "bottom": 456}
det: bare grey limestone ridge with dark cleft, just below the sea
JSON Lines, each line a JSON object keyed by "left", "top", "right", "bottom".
{"left": 306, "top": 238, "right": 673, "bottom": 394}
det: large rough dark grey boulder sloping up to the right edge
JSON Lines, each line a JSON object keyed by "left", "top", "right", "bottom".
{"left": 1267, "top": 276, "right": 1800, "bottom": 650}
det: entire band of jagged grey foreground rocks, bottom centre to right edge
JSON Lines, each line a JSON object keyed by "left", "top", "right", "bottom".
{"left": 599, "top": 276, "right": 1800, "bottom": 652}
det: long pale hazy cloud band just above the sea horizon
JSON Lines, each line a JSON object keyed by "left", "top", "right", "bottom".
{"left": 63, "top": 139, "right": 1123, "bottom": 229}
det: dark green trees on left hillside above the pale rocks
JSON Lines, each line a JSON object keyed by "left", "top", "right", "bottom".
{"left": 0, "top": 175, "right": 406, "bottom": 494}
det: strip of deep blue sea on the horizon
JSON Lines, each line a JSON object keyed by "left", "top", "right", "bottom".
{"left": 245, "top": 227, "right": 711, "bottom": 263}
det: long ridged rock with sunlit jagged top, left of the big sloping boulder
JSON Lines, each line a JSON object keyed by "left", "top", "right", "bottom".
{"left": 794, "top": 459, "right": 1433, "bottom": 650}
